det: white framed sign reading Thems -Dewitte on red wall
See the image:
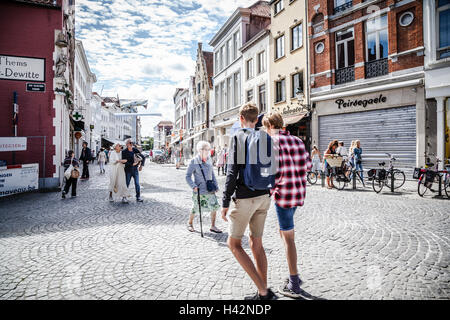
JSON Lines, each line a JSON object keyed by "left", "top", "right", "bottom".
{"left": 0, "top": 55, "right": 45, "bottom": 82}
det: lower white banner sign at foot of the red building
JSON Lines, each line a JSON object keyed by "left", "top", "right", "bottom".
{"left": 0, "top": 163, "right": 39, "bottom": 197}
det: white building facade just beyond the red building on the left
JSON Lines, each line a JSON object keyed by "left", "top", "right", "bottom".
{"left": 72, "top": 40, "right": 97, "bottom": 157}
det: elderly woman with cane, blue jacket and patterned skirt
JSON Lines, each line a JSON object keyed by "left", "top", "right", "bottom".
{"left": 186, "top": 141, "right": 222, "bottom": 233}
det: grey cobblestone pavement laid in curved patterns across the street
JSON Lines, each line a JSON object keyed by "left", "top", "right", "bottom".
{"left": 0, "top": 164, "right": 450, "bottom": 299}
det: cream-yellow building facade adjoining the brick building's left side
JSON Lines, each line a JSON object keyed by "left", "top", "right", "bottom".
{"left": 269, "top": 0, "right": 313, "bottom": 147}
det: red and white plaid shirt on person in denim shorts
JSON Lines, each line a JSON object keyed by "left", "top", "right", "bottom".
{"left": 271, "top": 130, "right": 311, "bottom": 208}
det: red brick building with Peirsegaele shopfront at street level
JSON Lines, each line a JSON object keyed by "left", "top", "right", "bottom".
{"left": 308, "top": 0, "right": 429, "bottom": 168}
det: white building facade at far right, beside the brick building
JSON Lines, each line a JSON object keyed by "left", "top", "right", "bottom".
{"left": 423, "top": 0, "right": 450, "bottom": 168}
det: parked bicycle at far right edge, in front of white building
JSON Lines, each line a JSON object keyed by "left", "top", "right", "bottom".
{"left": 415, "top": 158, "right": 450, "bottom": 198}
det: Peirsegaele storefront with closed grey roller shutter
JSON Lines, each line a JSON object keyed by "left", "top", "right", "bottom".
{"left": 312, "top": 86, "right": 426, "bottom": 169}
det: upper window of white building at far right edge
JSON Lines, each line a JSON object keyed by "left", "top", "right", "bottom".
{"left": 436, "top": 0, "right": 450, "bottom": 59}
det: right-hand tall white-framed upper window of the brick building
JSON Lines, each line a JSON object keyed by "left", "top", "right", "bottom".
{"left": 366, "top": 15, "right": 388, "bottom": 62}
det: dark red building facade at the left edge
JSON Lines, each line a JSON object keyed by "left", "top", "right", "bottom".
{"left": 0, "top": 0, "right": 75, "bottom": 188}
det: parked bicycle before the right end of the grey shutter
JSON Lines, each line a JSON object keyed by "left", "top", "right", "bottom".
{"left": 370, "top": 153, "right": 406, "bottom": 193}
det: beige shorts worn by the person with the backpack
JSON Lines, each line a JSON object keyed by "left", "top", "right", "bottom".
{"left": 229, "top": 194, "right": 270, "bottom": 239}
